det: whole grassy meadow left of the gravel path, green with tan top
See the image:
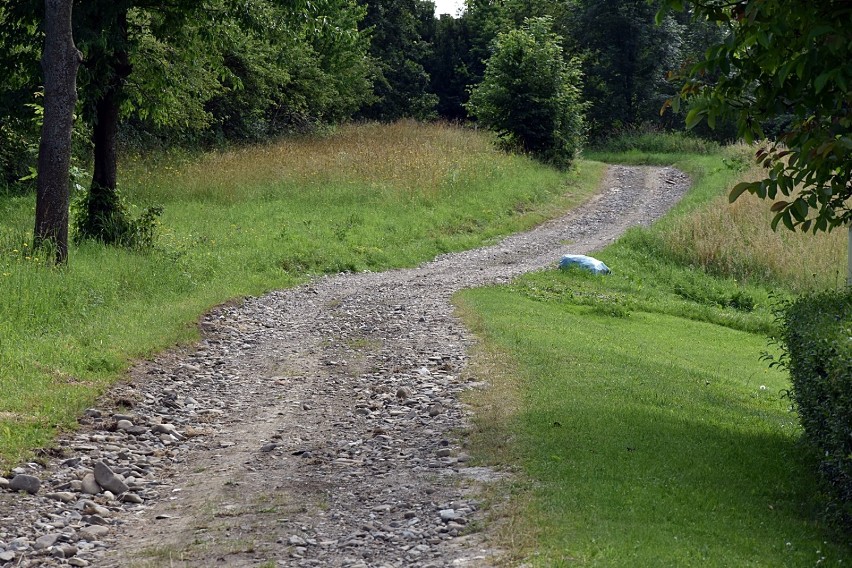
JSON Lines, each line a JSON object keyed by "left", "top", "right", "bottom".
{"left": 0, "top": 122, "right": 603, "bottom": 470}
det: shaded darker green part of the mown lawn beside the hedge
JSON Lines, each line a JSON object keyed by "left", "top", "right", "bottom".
{"left": 517, "top": 384, "right": 850, "bottom": 566}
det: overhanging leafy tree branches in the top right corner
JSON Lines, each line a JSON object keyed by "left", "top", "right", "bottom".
{"left": 658, "top": 0, "right": 852, "bottom": 232}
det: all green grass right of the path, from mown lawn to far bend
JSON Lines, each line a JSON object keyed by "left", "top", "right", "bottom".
{"left": 459, "top": 140, "right": 852, "bottom": 566}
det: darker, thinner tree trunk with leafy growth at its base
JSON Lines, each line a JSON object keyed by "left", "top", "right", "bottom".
{"left": 80, "top": 12, "right": 131, "bottom": 243}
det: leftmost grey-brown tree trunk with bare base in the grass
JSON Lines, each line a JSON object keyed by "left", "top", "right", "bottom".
{"left": 34, "top": 0, "right": 82, "bottom": 264}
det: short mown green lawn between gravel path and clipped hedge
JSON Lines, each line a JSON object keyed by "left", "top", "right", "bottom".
{"left": 460, "top": 286, "right": 850, "bottom": 566}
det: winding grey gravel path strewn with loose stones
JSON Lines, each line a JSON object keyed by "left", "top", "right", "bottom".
{"left": 0, "top": 166, "right": 688, "bottom": 568}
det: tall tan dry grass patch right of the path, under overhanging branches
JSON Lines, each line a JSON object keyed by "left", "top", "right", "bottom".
{"left": 664, "top": 154, "right": 847, "bottom": 292}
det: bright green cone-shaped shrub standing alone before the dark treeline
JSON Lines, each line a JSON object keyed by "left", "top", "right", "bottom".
{"left": 467, "top": 18, "right": 585, "bottom": 168}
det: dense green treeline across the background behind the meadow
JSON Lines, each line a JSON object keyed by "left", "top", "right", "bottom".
{"left": 0, "top": 0, "right": 716, "bottom": 191}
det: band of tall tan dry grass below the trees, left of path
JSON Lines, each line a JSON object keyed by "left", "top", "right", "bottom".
{"left": 127, "top": 121, "right": 506, "bottom": 201}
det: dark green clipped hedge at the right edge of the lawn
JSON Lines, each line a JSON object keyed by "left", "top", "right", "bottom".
{"left": 780, "top": 288, "right": 852, "bottom": 529}
